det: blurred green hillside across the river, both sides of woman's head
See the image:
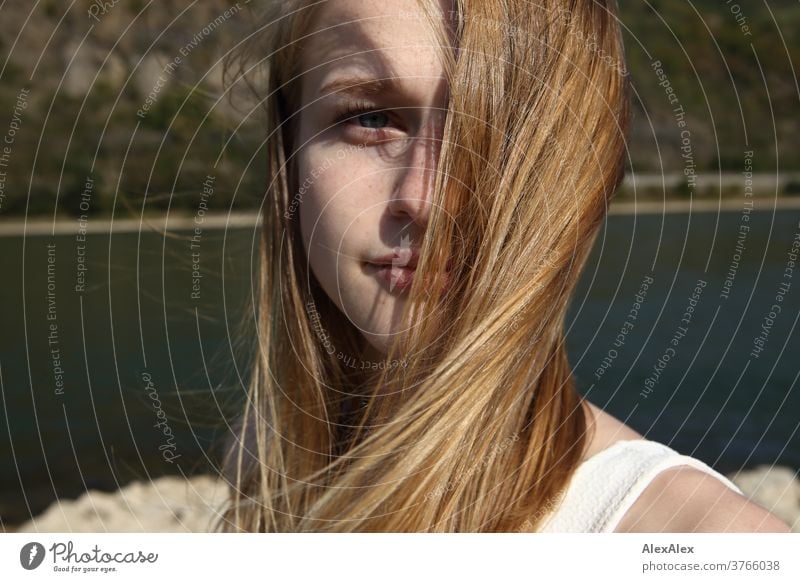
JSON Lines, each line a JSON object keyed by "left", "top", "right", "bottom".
{"left": 0, "top": 0, "right": 800, "bottom": 218}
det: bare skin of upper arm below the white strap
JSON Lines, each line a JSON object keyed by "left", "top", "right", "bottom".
{"left": 615, "top": 465, "right": 791, "bottom": 533}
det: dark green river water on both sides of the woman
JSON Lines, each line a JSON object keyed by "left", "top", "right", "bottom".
{"left": 0, "top": 210, "right": 800, "bottom": 521}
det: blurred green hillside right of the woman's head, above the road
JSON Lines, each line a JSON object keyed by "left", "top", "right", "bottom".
{"left": 621, "top": 0, "right": 800, "bottom": 173}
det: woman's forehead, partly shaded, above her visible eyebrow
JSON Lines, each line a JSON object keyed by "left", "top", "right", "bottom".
{"left": 302, "top": 0, "right": 446, "bottom": 88}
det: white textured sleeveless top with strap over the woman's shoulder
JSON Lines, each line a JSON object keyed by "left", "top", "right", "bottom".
{"left": 539, "top": 439, "right": 742, "bottom": 533}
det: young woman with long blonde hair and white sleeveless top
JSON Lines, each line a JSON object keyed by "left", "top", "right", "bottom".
{"left": 220, "top": 0, "right": 787, "bottom": 532}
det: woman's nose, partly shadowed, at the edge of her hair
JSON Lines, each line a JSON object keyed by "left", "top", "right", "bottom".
{"left": 389, "top": 130, "right": 441, "bottom": 227}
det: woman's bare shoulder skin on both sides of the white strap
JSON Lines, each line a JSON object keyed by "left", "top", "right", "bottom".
{"left": 583, "top": 400, "right": 791, "bottom": 533}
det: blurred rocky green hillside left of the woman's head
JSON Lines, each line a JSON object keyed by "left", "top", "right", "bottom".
{"left": 0, "top": 0, "right": 263, "bottom": 218}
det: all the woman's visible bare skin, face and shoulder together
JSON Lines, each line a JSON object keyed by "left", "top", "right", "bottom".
{"left": 296, "top": 0, "right": 789, "bottom": 532}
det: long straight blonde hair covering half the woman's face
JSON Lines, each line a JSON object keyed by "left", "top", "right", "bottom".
{"left": 218, "top": 0, "right": 628, "bottom": 532}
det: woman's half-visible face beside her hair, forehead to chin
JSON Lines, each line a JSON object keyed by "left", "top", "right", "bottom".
{"left": 290, "top": 0, "right": 454, "bottom": 353}
